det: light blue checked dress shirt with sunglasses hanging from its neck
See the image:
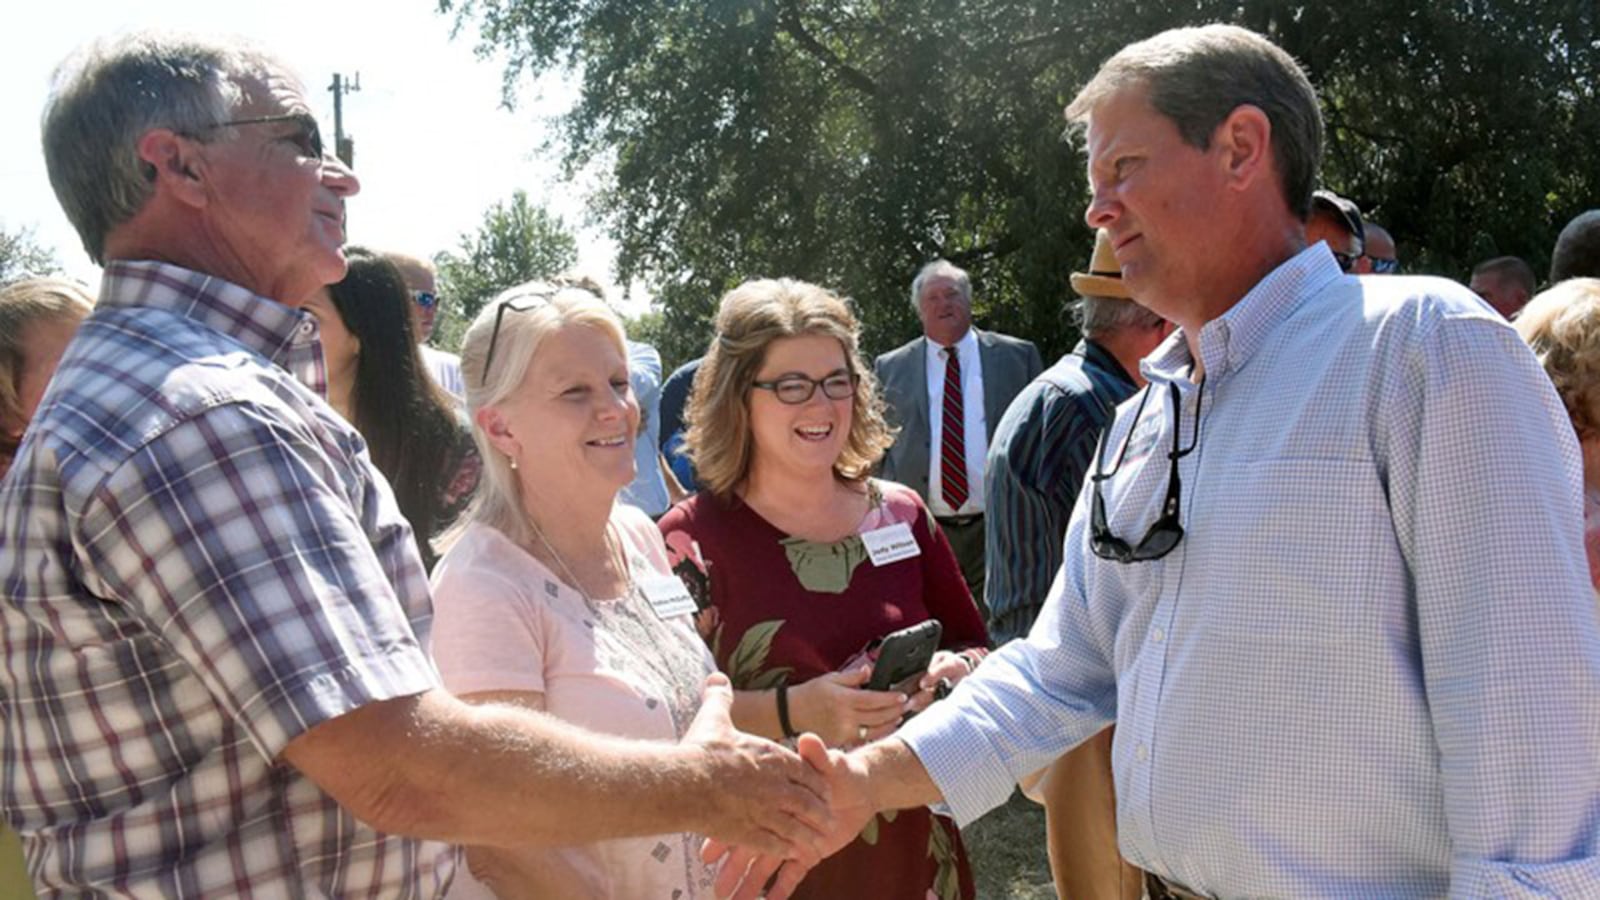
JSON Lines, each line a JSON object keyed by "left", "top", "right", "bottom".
{"left": 901, "top": 245, "right": 1600, "bottom": 898}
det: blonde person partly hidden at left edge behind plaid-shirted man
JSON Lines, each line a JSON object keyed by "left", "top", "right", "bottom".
{"left": 0, "top": 279, "right": 94, "bottom": 477}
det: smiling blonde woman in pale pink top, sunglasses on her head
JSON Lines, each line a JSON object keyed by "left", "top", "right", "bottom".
{"left": 434, "top": 283, "right": 715, "bottom": 900}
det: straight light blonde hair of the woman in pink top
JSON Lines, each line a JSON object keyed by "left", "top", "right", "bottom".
{"left": 461, "top": 282, "right": 627, "bottom": 544}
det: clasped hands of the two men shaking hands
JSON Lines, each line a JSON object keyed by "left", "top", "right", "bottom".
{"left": 683, "top": 674, "right": 939, "bottom": 900}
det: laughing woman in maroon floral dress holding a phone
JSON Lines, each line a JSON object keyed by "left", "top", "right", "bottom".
{"left": 661, "top": 280, "right": 987, "bottom": 900}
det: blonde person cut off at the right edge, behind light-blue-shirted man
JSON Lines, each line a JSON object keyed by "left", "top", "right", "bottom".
{"left": 1514, "top": 279, "right": 1600, "bottom": 591}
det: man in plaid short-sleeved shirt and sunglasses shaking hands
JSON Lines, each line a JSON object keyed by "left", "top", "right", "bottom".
{"left": 0, "top": 35, "right": 827, "bottom": 898}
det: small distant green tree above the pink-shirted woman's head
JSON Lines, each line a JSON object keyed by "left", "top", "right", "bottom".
{"left": 434, "top": 191, "right": 578, "bottom": 349}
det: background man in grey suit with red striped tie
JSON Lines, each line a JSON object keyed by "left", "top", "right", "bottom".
{"left": 874, "top": 259, "right": 1045, "bottom": 605}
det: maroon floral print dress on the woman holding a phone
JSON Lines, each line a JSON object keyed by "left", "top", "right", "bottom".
{"left": 659, "top": 482, "right": 987, "bottom": 900}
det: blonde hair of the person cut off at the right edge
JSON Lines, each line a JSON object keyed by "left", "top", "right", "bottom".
{"left": 1515, "top": 279, "right": 1600, "bottom": 437}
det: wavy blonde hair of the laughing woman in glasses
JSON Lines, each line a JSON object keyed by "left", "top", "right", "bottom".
{"left": 685, "top": 279, "right": 894, "bottom": 498}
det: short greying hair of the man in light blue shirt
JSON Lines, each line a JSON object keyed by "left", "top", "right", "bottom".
{"left": 1067, "top": 26, "right": 1322, "bottom": 219}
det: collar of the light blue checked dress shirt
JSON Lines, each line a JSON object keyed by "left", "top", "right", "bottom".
{"left": 1139, "top": 242, "right": 1342, "bottom": 386}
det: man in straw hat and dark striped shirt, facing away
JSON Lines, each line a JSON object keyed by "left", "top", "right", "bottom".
{"left": 984, "top": 231, "right": 1171, "bottom": 900}
